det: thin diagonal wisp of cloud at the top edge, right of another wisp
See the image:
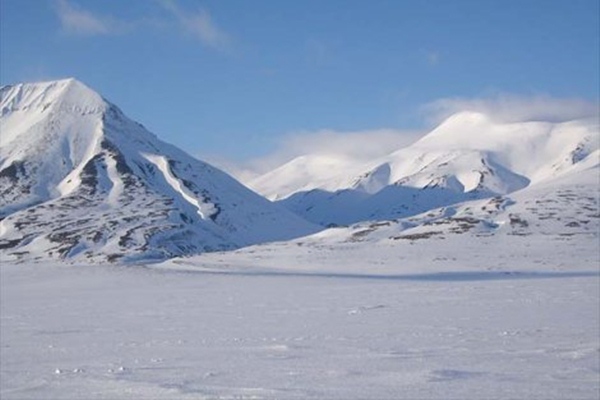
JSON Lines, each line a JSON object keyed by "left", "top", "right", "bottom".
{"left": 160, "top": 0, "right": 230, "bottom": 50}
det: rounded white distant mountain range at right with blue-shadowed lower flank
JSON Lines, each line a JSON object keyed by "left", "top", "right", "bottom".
{"left": 249, "top": 112, "right": 600, "bottom": 225}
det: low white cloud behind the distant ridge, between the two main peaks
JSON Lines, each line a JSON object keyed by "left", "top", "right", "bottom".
{"left": 209, "top": 129, "right": 422, "bottom": 182}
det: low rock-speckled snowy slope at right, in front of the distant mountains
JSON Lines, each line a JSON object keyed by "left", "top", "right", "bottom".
{"left": 288, "top": 150, "right": 600, "bottom": 250}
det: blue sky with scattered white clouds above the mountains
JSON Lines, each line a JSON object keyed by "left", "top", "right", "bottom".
{"left": 0, "top": 0, "right": 600, "bottom": 178}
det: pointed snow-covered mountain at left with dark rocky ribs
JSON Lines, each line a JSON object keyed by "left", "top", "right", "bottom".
{"left": 0, "top": 79, "right": 317, "bottom": 261}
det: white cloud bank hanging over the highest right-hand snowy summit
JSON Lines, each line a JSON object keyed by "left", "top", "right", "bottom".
{"left": 423, "top": 94, "right": 599, "bottom": 123}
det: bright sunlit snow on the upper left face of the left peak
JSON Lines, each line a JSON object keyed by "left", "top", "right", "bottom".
{"left": 0, "top": 79, "right": 107, "bottom": 208}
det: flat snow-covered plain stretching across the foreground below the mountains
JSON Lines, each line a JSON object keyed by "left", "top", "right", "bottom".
{"left": 0, "top": 236, "right": 600, "bottom": 399}
